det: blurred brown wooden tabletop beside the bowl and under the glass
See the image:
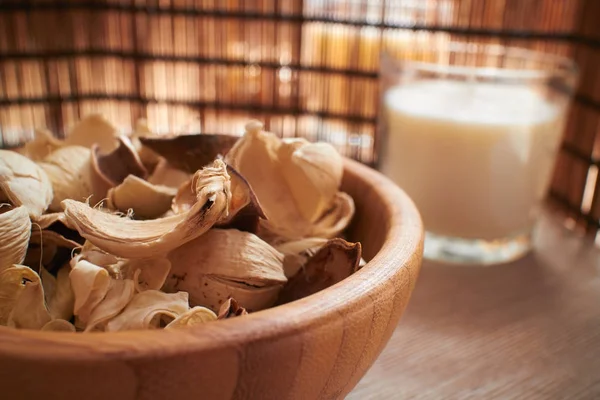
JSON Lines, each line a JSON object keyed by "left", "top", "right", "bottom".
{"left": 347, "top": 211, "right": 600, "bottom": 400}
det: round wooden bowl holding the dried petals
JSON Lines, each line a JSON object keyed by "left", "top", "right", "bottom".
{"left": 0, "top": 161, "right": 423, "bottom": 400}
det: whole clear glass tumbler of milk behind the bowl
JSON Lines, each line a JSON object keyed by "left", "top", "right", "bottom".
{"left": 377, "top": 43, "right": 577, "bottom": 264}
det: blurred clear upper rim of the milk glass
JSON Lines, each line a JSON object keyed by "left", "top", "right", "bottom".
{"left": 380, "top": 42, "right": 579, "bottom": 80}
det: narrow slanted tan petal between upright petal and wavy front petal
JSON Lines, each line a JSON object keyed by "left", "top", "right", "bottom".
{"left": 84, "top": 279, "right": 135, "bottom": 332}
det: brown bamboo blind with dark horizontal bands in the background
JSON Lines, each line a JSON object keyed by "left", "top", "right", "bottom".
{"left": 0, "top": 0, "right": 600, "bottom": 232}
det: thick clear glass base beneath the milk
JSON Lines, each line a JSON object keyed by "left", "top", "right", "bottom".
{"left": 424, "top": 232, "right": 531, "bottom": 265}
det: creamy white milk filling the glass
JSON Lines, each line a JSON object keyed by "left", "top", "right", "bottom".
{"left": 381, "top": 79, "right": 564, "bottom": 240}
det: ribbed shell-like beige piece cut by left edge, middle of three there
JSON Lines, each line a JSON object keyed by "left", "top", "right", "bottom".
{"left": 0, "top": 205, "right": 31, "bottom": 271}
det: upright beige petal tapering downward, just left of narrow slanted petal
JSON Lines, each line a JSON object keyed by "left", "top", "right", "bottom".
{"left": 69, "top": 259, "right": 111, "bottom": 323}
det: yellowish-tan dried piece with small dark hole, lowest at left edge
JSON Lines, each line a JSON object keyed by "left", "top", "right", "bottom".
{"left": 0, "top": 265, "right": 51, "bottom": 329}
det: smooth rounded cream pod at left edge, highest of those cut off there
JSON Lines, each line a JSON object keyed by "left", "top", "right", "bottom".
{"left": 0, "top": 149, "right": 53, "bottom": 220}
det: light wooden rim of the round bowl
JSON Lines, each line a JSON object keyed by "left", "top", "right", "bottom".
{"left": 0, "top": 159, "right": 424, "bottom": 363}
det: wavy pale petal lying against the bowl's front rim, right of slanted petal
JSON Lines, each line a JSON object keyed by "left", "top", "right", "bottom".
{"left": 106, "top": 290, "right": 189, "bottom": 332}
